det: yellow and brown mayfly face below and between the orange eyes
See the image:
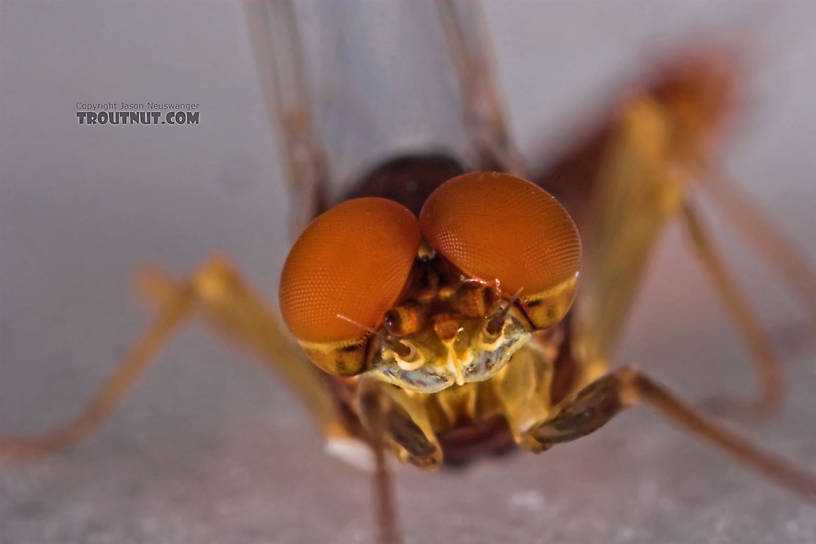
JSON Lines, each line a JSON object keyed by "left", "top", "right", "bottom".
{"left": 368, "top": 276, "right": 533, "bottom": 393}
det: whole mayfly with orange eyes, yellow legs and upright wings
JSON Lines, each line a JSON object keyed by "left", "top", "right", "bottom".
{"left": 0, "top": 2, "right": 816, "bottom": 542}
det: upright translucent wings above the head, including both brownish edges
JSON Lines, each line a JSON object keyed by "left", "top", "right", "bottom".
{"left": 245, "top": 0, "right": 522, "bottom": 224}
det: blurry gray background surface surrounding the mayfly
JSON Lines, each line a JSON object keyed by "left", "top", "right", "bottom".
{"left": 0, "top": 1, "right": 816, "bottom": 544}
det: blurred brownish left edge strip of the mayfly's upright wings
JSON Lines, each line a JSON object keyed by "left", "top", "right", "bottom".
{"left": 243, "top": 0, "right": 327, "bottom": 234}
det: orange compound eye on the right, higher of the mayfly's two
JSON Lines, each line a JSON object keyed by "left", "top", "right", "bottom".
{"left": 419, "top": 172, "right": 581, "bottom": 328}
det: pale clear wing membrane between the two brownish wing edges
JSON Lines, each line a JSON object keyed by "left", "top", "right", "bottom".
{"left": 299, "top": 1, "right": 474, "bottom": 192}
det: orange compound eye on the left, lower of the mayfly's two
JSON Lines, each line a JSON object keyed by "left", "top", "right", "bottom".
{"left": 279, "top": 198, "right": 420, "bottom": 376}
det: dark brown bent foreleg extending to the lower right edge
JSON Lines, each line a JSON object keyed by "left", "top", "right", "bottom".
{"left": 530, "top": 366, "right": 816, "bottom": 502}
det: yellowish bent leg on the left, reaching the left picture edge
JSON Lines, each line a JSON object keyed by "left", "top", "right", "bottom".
{"left": 0, "top": 258, "right": 354, "bottom": 458}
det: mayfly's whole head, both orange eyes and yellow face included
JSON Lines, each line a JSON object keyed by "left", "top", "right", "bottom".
{"left": 280, "top": 172, "right": 581, "bottom": 392}
